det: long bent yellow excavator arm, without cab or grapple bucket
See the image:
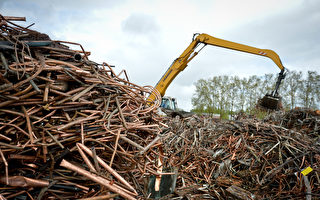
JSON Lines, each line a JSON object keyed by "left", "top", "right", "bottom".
{"left": 147, "top": 33, "right": 285, "bottom": 106}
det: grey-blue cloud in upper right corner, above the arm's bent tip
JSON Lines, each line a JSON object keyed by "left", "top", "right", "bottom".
{"left": 229, "top": 0, "right": 320, "bottom": 71}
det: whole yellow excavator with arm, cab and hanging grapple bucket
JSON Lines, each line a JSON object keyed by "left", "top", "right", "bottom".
{"left": 147, "top": 33, "right": 286, "bottom": 110}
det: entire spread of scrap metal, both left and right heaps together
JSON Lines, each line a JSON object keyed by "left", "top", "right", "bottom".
{"left": 0, "top": 15, "right": 320, "bottom": 200}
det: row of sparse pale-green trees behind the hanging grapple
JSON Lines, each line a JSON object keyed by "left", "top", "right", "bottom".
{"left": 191, "top": 71, "right": 320, "bottom": 114}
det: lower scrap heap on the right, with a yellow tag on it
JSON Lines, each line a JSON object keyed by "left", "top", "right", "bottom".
{"left": 165, "top": 111, "right": 320, "bottom": 199}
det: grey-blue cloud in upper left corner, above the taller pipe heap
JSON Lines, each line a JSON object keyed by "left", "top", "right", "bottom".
{"left": 0, "top": 0, "right": 125, "bottom": 33}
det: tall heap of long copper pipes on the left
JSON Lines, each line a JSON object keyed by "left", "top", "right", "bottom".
{"left": 0, "top": 16, "right": 167, "bottom": 199}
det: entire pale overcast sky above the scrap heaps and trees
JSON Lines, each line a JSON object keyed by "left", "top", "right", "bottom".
{"left": 0, "top": 0, "right": 320, "bottom": 110}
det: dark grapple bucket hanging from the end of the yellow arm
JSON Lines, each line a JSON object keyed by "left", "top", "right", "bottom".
{"left": 258, "top": 70, "right": 286, "bottom": 110}
